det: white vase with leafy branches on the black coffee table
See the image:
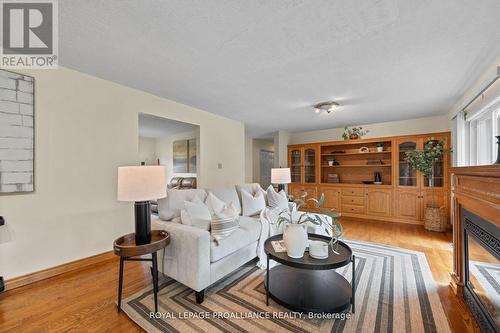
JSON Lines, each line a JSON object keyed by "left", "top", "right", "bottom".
{"left": 276, "top": 191, "right": 343, "bottom": 258}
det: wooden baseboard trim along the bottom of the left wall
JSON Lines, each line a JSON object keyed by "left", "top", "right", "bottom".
{"left": 5, "top": 251, "right": 118, "bottom": 291}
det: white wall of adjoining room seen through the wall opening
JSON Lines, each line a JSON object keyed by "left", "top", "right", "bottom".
{"left": 156, "top": 131, "right": 200, "bottom": 183}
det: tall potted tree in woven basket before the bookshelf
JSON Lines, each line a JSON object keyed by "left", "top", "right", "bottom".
{"left": 405, "top": 138, "right": 447, "bottom": 231}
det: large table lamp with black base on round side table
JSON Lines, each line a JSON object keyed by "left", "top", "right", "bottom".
{"left": 118, "top": 165, "right": 167, "bottom": 245}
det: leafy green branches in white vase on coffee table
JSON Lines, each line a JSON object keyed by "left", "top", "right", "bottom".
{"left": 276, "top": 191, "right": 344, "bottom": 252}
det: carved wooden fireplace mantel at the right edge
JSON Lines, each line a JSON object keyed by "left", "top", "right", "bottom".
{"left": 451, "top": 164, "right": 500, "bottom": 297}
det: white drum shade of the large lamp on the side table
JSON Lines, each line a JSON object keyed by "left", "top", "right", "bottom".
{"left": 118, "top": 165, "right": 167, "bottom": 201}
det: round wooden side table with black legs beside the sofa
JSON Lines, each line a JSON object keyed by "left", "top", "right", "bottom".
{"left": 113, "top": 230, "right": 170, "bottom": 312}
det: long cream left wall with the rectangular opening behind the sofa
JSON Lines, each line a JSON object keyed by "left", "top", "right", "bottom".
{"left": 0, "top": 67, "right": 245, "bottom": 279}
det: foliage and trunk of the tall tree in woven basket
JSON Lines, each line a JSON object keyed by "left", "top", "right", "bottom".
{"left": 405, "top": 137, "right": 447, "bottom": 208}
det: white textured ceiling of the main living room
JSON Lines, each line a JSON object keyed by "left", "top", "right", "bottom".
{"left": 59, "top": 0, "right": 500, "bottom": 135}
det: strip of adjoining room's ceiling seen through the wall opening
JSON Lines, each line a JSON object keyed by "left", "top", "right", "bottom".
{"left": 139, "top": 113, "right": 198, "bottom": 138}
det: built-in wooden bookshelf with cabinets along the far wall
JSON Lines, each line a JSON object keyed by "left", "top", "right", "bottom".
{"left": 288, "top": 132, "right": 450, "bottom": 224}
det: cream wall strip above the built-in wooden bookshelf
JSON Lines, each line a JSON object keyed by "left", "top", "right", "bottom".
{"left": 290, "top": 115, "right": 451, "bottom": 144}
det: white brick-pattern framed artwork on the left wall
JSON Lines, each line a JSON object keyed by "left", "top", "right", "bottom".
{"left": 0, "top": 69, "right": 35, "bottom": 194}
